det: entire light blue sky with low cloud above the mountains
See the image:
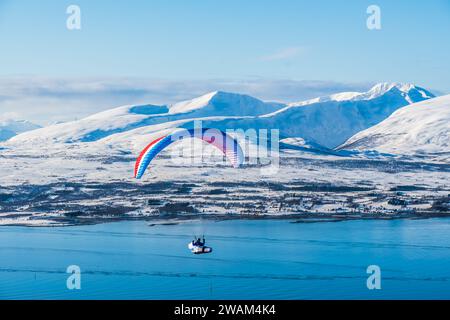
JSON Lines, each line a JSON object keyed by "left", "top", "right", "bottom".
{"left": 0, "top": 0, "right": 450, "bottom": 123}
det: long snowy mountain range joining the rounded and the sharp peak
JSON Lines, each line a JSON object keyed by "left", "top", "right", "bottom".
{"left": 10, "top": 83, "right": 433, "bottom": 148}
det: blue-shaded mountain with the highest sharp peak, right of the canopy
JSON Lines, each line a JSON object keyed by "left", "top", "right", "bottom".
{"left": 200, "top": 83, "right": 433, "bottom": 148}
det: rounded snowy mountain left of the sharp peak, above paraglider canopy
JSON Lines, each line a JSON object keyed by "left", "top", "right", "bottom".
{"left": 11, "top": 92, "right": 284, "bottom": 143}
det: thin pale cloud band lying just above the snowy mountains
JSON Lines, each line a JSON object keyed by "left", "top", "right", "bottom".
{"left": 0, "top": 77, "right": 372, "bottom": 125}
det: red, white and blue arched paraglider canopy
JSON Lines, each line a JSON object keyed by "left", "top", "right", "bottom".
{"left": 134, "top": 128, "right": 244, "bottom": 179}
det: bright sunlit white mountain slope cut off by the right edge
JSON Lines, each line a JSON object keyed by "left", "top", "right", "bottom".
{"left": 339, "top": 95, "right": 450, "bottom": 154}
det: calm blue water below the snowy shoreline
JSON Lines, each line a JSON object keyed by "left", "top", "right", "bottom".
{"left": 0, "top": 219, "right": 450, "bottom": 299}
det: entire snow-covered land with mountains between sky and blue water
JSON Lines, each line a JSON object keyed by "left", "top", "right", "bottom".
{"left": 0, "top": 83, "right": 450, "bottom": 225}
